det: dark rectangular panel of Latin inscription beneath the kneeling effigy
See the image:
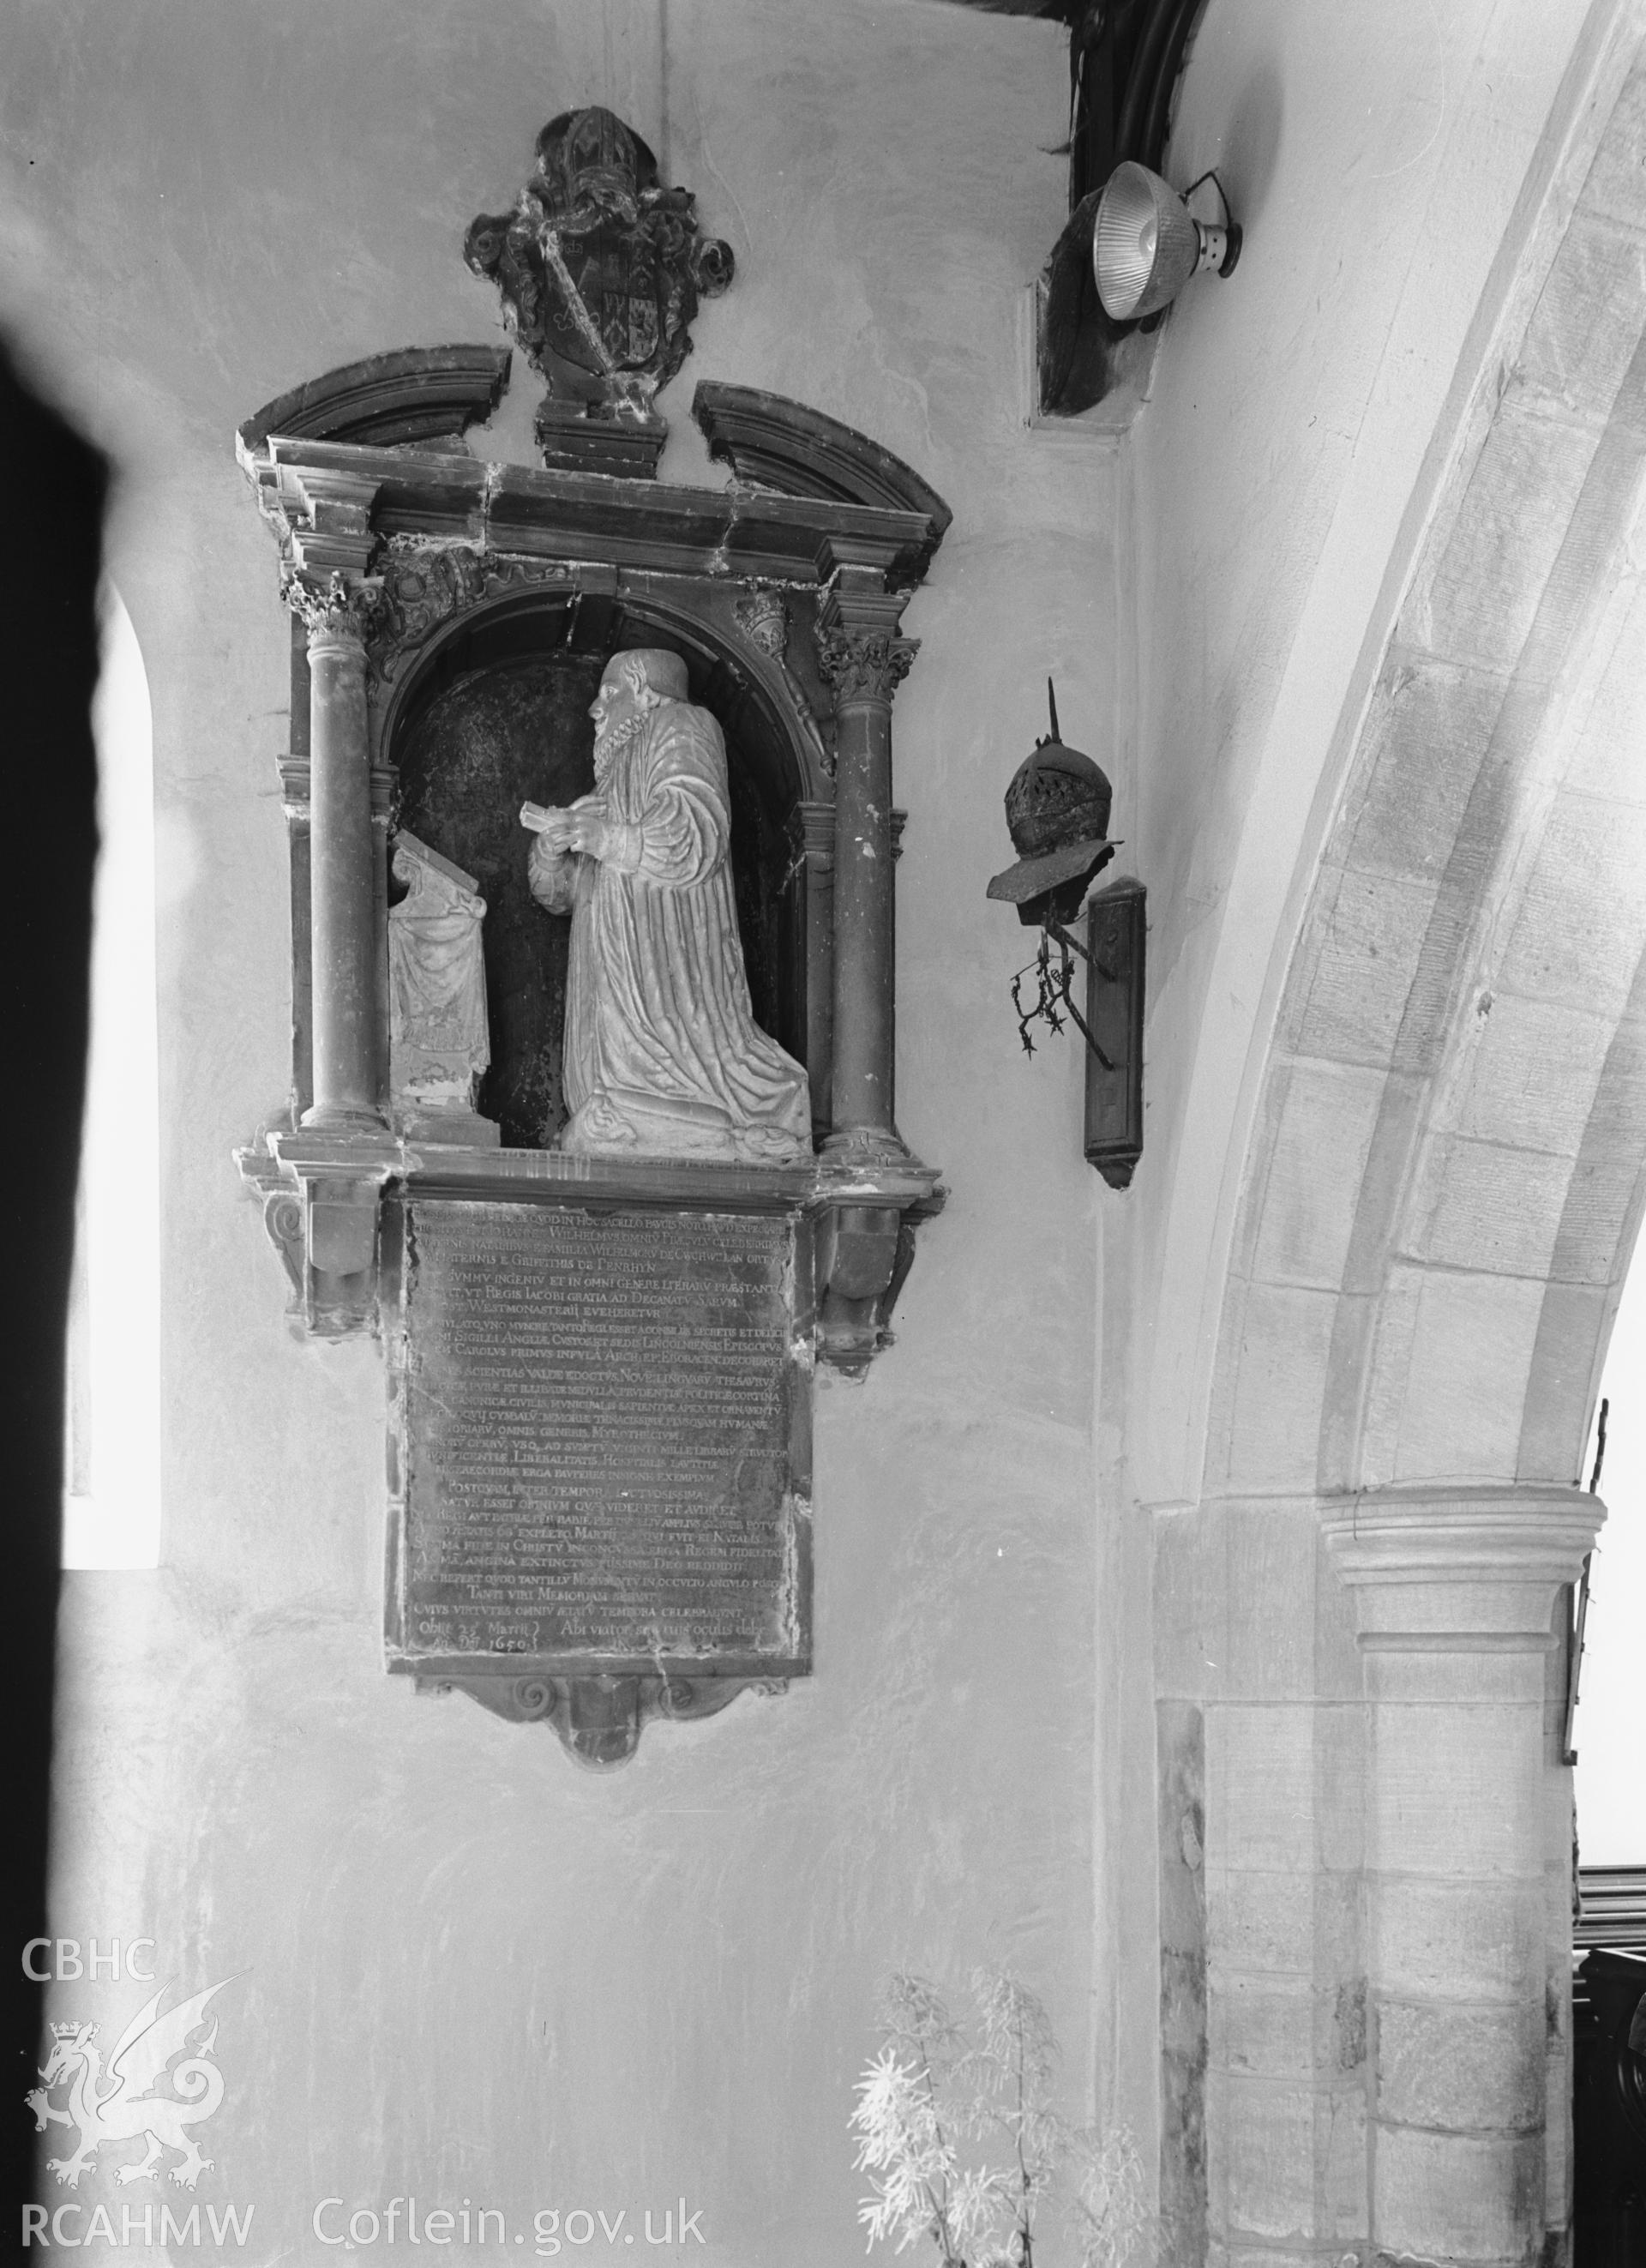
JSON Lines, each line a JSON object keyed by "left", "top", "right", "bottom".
{"left": 387, "top": 1198, "right": 809, "bottom": 1674}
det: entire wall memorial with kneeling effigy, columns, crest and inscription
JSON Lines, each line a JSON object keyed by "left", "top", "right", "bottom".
{"left": 238, "top": 111, "right": 950, "bottom": 1765}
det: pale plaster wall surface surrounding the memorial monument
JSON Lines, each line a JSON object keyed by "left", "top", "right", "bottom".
{"left": 0, "top": 0, "right": 1129, "bottom": 2268}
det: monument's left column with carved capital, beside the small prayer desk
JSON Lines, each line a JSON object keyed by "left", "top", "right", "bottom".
{"left": 285, "top": 574, "right": 386, "bottom": 1132}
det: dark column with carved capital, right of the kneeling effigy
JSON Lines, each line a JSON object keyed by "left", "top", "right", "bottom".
{"left": 816, "top": 576, "right": 918, "bottom": 1164}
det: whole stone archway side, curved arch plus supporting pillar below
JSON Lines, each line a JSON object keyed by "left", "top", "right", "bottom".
{"left": 1156, "top": 29, "right": 1646, "bottom": 2261}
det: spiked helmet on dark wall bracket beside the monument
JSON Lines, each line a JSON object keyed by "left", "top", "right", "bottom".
{"left": 988, "top": 684, "right": 1145, "bottom": 1188}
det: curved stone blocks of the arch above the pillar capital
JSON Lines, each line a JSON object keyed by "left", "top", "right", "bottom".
{"left": 1206, "top": 261, "right": 1646, "bottom": 1492}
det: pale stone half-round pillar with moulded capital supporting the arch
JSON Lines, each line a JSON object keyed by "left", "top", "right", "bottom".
{"left": 1324, "top": 1485, "right": 1605, "bottom": 2268}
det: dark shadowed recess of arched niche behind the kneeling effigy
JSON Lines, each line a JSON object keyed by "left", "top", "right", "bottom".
{"left": 379, "top": 587, "right": 827, "bottom": 1147}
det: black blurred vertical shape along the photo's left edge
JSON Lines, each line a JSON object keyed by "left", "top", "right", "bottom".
{"left": 0, "top": 340, "right": 109, "bottom": 2225}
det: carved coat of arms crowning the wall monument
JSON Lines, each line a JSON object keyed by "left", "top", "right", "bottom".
{"left": 463, "top": 109, "right": 732, "bottom": 466}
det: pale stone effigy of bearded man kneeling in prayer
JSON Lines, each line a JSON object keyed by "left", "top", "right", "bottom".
{"left": 521, "top": 647, "right": 812, "bottom": 1166}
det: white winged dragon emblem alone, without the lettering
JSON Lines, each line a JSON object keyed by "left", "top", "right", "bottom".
{"left": 22, "top": 1977, "right": 231, "bottom": 2188}
